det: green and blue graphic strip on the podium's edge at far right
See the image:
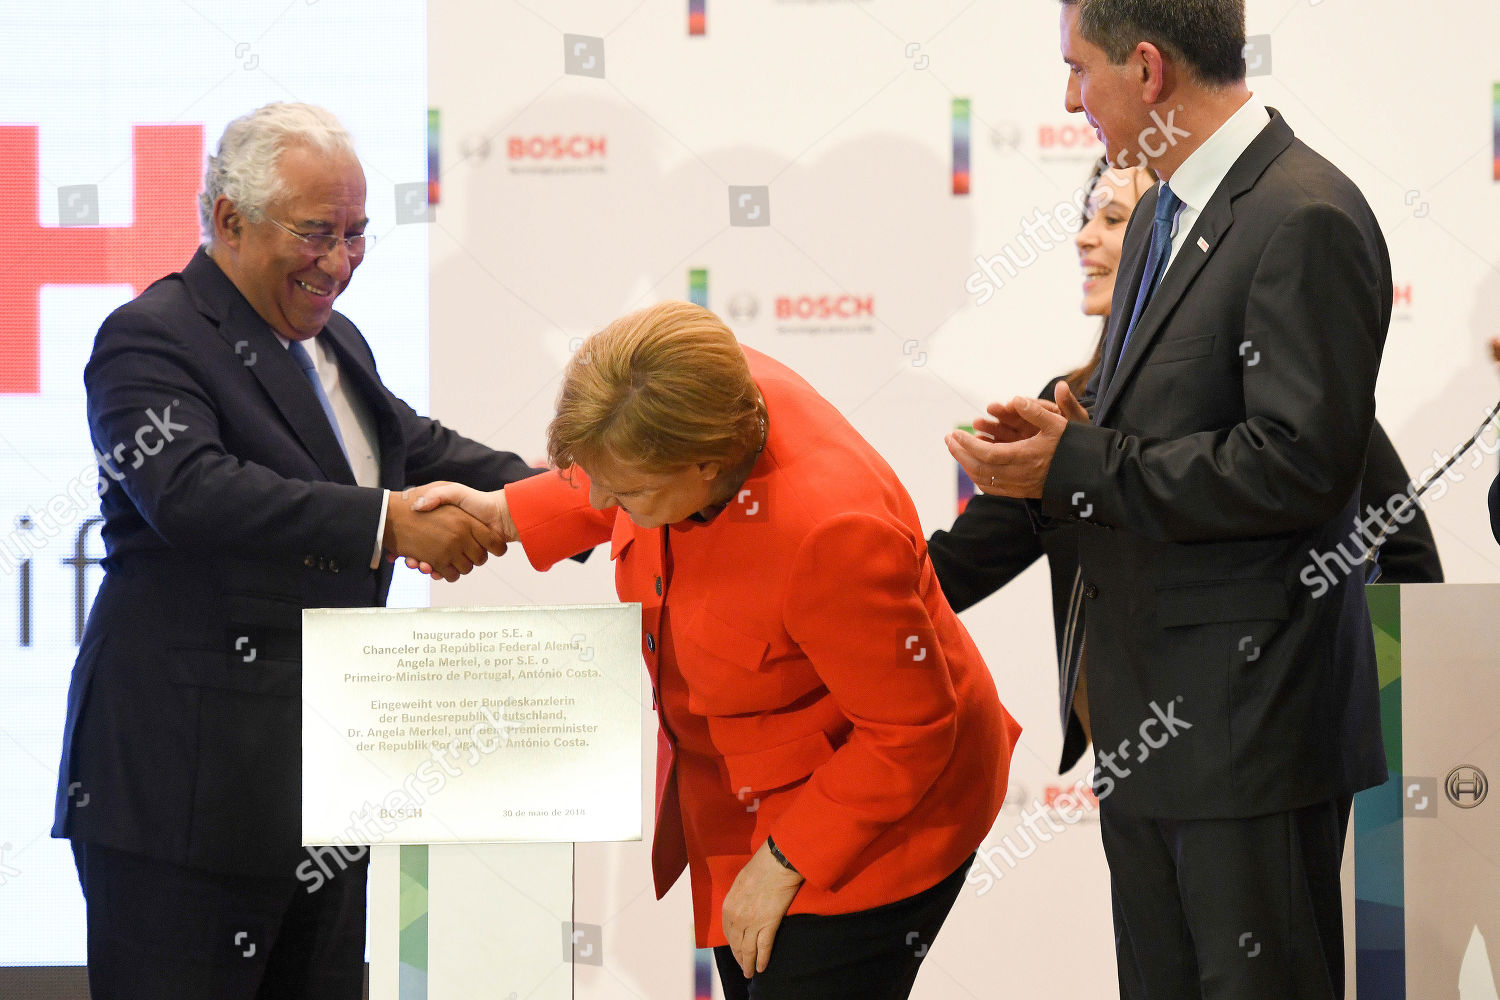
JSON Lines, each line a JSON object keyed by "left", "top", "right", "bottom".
{"left": 1355, "top": 583, "right": 1406, "bottom": 1000}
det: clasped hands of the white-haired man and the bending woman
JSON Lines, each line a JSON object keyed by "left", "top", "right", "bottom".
{"left": 384, "top": 483, "right": 519, "bottom": 583}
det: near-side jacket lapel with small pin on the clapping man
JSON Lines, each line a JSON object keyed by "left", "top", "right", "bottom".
{"left": 1094, "top": 108, "right": 1293, "bottom": 424}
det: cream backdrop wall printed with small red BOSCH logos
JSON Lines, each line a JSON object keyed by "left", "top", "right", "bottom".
{"left": 429, "top": 0, "right": 1500, "bottom": 999}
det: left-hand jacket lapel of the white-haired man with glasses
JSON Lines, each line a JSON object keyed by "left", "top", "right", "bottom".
{"left": 183, "top": 249, "right": 354, "bottom": 484}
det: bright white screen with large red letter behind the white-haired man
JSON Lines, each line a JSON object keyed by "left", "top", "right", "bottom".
{"left": 0, "top": 0, "right": 428, "bottom": 971}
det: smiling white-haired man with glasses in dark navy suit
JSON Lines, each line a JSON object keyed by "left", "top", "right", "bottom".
{"left": 53, "top": 105, "right": 534, "bottom": 1000}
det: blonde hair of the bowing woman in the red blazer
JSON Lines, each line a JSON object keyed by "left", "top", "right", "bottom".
{"left": 548, "top": 301, "right": 765, "bottom": 474}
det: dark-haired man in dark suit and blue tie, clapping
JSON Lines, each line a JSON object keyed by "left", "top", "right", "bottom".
{"left": 950, "top": 0, "right": 1392, "bottom": 1000}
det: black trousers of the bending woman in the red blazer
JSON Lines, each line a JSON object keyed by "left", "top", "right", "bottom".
{"left": 714, "top": 856, "right": 974, "bottom": 1000}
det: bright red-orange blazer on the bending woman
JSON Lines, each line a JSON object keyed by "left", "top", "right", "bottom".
{"left": 506, "top": 349, "right": 1020, "bottom": 948}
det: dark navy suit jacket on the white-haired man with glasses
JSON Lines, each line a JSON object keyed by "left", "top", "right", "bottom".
{"left": 53, "top": 250, "right": 534, "bottom": 876}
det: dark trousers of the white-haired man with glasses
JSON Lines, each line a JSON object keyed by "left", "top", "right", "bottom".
{"left": 74, "top": 841, "right": 369, "bottom": 1000}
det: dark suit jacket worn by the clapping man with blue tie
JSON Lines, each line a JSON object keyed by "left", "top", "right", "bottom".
{"left": 1041, "top": 112, "right": 1392, "bottom": 819}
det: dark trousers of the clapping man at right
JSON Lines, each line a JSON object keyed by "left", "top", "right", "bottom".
{"left": 1100, "top": 798, "right": 1352, "bottom": 1000}
